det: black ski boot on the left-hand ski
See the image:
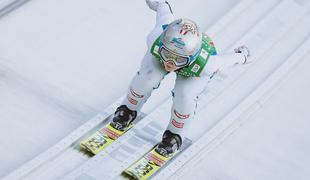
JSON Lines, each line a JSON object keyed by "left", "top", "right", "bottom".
{"left": 110, "top": 105, "right": 137, "bottom": 131}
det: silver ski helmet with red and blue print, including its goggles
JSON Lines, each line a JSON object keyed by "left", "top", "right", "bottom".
{"left": 159, "top": 19, "right": 202, "bottom": 68}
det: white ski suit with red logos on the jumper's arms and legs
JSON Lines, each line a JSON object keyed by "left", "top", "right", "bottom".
{"left": 122, "top": 3, "right": 245, "bottom": 140}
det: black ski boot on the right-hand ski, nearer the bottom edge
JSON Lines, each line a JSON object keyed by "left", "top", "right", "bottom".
{"left": 155, "top": 130, "right": 182, "bottom": 158}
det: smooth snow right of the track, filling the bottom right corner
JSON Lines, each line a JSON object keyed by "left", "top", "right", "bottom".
{"left": 183, "top": 51, "right": 310, "bottom": 180}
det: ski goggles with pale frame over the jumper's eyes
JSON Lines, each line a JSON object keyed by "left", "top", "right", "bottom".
{"left": 159, "top": 46, "right": 190, "bottom": 67}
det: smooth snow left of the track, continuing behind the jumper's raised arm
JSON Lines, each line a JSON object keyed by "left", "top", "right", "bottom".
{"left": 0, "top": 0, "right": 238, "bottom": 177}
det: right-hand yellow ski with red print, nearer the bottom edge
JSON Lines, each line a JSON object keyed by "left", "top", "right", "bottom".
{"left": 123, "top": 138, "right": 191, "bottom": 180}
